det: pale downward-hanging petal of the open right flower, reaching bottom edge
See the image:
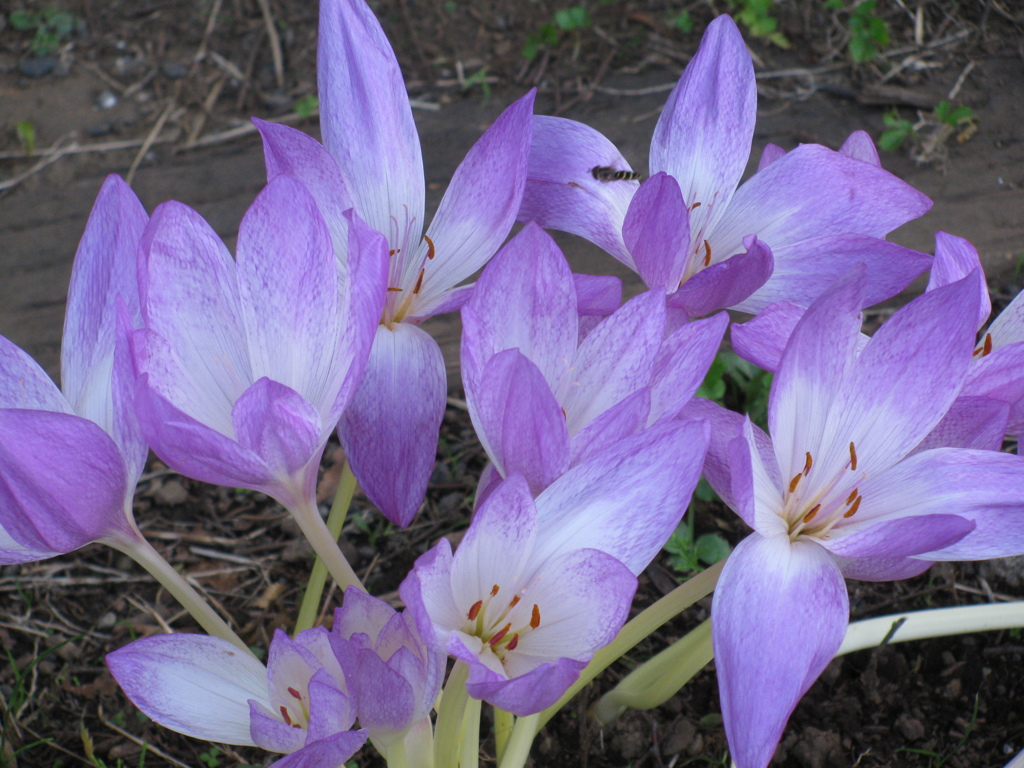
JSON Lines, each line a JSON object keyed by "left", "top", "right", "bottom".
{"left": 712, "top": 534, "right": 850, "bottom": 768}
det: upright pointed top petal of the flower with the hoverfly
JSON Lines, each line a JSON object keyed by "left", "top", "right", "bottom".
{"left": 650, "top": 15, "right": 758, "bottom": 234}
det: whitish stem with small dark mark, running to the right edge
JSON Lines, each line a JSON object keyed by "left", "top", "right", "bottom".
{"left": 836, "top": 601, "right": 1024, "bottom": 655}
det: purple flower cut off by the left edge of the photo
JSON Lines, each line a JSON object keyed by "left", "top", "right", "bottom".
{"left": 0, "top": 176, "right": 147, "bottom": 563}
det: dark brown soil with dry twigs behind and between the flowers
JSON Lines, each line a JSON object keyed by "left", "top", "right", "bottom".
{"left": 0, "top": 0, "right": 1024, "bottom": 768}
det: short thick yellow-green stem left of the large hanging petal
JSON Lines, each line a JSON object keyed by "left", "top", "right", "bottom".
{"left": 593, "top": 618, "right": 715, "bottom": 725}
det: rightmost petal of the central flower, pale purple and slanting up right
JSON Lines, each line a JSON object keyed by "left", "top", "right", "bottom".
{"left": 649, "top": 312, "right": 729, "bottom": 423}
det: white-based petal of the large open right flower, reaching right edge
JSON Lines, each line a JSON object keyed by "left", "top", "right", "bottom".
{"left": 853, "top": 449, "right": 1024, "bottom": 560}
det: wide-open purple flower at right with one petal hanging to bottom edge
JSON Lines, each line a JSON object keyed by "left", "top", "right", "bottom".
{"left": 683, "top": 267, "right": 1024, "bottom": 768}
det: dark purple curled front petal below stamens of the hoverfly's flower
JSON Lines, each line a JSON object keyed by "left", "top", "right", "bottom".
{"left": 669, "top": 236, "right": 775, "bottom": 317}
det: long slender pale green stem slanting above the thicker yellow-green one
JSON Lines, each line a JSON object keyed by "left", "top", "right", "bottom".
{"left": 536, "top": 560, "right": 725, "bottom": 729}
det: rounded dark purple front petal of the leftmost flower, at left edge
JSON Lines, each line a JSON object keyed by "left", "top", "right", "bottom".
{"left": 0, "top": 409, "right": 136, "bottom": 557}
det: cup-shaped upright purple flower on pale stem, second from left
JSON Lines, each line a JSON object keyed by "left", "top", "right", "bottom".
{"left": 132, "top": 175, "right": 387, "bottom": 584}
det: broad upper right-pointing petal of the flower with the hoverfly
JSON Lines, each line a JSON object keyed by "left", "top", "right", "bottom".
{"left": 710, "top": 144, "right": 932, "bottom": 264}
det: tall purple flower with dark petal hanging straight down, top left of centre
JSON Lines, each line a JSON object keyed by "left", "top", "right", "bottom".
{"left": 251, "top": 0, "right": 534, "bottom": 526}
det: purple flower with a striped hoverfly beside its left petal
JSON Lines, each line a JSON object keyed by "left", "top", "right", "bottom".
{"left": 519, "top": 16, "right": 931, "bottom": 316}
